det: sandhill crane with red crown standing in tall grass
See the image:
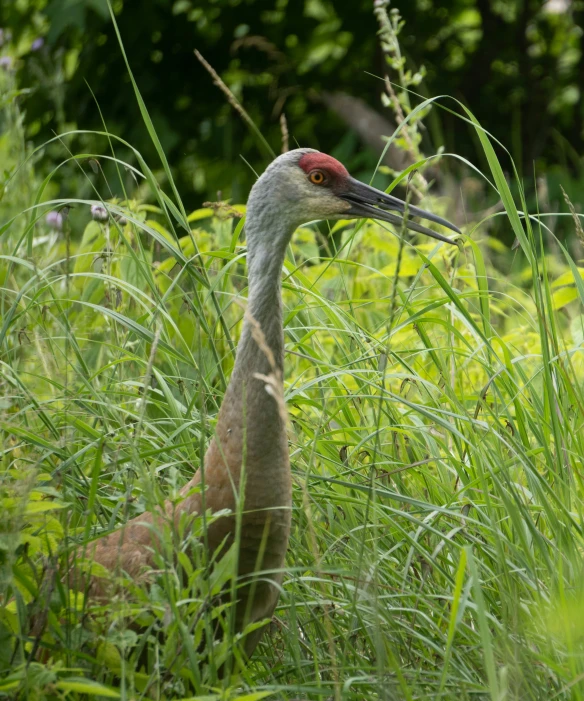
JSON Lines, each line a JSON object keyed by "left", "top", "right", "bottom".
{"left": 70, "top": 148, "right": 460, "bottom": 655}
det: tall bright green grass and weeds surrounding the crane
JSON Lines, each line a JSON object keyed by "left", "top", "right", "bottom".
{"left": 0, "top": 35, "right": 584, "bottom": 701}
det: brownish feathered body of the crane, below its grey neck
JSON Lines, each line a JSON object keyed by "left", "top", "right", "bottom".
{"left": 86, "top": 356, "right": 291, "bottom": 654}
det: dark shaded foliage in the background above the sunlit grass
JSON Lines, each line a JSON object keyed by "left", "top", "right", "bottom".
{"left": 0, "top": 0, "right": 584, "bottom": 221}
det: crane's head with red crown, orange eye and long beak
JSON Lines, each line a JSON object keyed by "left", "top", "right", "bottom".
{"left": 248, "top": 148, "right": 461, "bottom": 243}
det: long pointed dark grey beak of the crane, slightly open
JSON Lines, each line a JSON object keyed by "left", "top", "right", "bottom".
{"left": 339, "top": 177, "right": 462, "bottom": 244}
